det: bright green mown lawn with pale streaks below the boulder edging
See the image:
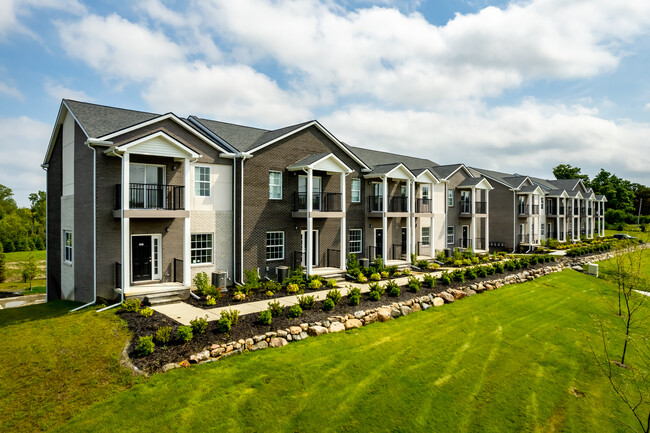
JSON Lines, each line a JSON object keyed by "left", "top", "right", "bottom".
{"left": 57, "top": 270, "right": 635, "bottom": 433}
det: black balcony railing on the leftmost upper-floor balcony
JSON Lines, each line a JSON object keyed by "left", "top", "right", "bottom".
{"left": 115, "top": 183, "right": 185, "bottom": 210}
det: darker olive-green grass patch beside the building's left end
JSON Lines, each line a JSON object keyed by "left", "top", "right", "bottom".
{"left": 0, "top": 301, "right": 134, "bottom": 432}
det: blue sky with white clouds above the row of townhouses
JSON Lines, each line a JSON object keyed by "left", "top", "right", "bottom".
{"left": 0, "top": 0, "right": 650, "bottom": 205}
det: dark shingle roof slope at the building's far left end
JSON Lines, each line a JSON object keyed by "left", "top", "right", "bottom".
{"left": 63, "top": 99, "right": 160, "bottom": 138}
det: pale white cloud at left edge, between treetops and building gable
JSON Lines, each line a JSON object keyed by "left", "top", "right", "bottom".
{"left": 0, "top": 116, "right": 52, "bottom": 205}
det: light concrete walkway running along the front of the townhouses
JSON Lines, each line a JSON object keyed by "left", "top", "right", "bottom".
{"left": 151, "top": 270, "right": 442, "bottom": 326}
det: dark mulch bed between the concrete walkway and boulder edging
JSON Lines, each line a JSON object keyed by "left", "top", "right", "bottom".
{"left": 118, "top": 263, "right": 555, "bottom": 373}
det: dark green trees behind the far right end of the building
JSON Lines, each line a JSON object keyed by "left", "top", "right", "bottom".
{"left": 553, "top": 164, "right": 650, "bottom": 226}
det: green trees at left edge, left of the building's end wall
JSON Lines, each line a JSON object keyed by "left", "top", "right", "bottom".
{"left": 0, "top": 184, "right": 45, "bottom": 253}
